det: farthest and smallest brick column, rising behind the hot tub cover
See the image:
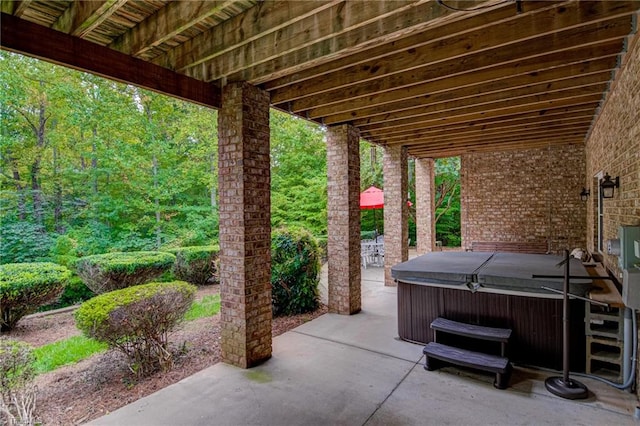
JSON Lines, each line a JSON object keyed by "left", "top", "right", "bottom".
{"left": 416, "top": 158, "right": 436, "bottom": 254}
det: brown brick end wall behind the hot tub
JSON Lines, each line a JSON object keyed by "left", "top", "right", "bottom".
{"left": 461, "top": 145, "right": 586, "bottom": 253}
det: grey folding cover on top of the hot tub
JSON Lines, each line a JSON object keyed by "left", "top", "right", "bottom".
{"left": 391, "top": 252, "right": 591, "bottom": 296}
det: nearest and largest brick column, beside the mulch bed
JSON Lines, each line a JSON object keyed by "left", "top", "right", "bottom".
{"left": 218, "top": 83, "right": 272, "bottom": 368}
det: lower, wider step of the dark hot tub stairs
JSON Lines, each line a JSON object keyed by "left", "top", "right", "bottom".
{"left": 422, "top": 342, "right": 511, "bottom": 389}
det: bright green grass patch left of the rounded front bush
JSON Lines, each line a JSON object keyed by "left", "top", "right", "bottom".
{"left": 33, "top": 336, "right": 107, "bottom": 374}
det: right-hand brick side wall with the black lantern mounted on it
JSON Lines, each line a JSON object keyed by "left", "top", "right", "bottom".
{"left": 584, "top": 30, "right": 640, "bottom": 276}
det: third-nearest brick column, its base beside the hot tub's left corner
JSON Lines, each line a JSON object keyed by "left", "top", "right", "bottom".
{"left": 383, "top": 146, "right": 409, "bottom": 286}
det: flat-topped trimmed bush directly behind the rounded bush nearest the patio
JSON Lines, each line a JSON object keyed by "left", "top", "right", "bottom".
{"left": 76, "top": 251, "right": 176, "bottom": 294}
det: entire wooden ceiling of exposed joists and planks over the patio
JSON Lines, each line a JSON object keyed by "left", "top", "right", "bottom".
{"left": 2, "top": 0, "right": 640, "bottom": 157}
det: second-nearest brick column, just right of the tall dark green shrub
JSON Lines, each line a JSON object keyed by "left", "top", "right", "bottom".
{"left": 327, "top": 124, "right": 361, "bottom": 315}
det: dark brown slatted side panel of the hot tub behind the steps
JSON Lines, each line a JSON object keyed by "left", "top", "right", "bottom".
{"left": 398, "top": 282, "right": 586, "bottom": 371}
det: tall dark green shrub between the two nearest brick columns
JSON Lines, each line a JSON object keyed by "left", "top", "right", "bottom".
{"left": 271, "top": 229, "right": 320, "bottom": 316}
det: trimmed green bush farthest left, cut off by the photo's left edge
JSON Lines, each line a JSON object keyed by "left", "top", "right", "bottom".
{"left": 0, "top": 262, "right": 71, "bottom": 331}
